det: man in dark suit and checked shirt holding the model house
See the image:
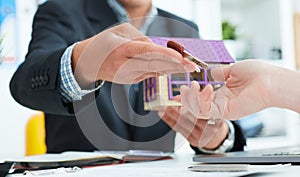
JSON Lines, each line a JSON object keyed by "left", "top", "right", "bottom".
{"left": 10, "top": 0, "right": 245, "bottom": 152}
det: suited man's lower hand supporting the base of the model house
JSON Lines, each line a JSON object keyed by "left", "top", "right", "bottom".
{"left": 158, "top": 106, "right": 229, "bottom": 150}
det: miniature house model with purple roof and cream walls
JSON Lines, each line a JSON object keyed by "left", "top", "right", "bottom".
{"left": 144, "top": 37, "right": 234, "bottom": 110}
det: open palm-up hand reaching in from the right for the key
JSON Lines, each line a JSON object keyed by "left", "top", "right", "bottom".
{"left": 176, "top": 60, "right": 274, "bottom": 120}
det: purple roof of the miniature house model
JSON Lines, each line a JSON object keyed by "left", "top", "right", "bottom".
{"left": 150, "top": 37, "right": 234, "bottom": 64}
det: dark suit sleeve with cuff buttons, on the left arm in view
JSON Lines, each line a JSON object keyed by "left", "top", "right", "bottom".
{"left": 10, "top": 1, "right": 88, "bottom": 115}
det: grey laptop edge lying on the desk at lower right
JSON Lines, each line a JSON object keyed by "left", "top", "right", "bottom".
{"left": 193, "top": 146, "right": 300, "bottom": 165}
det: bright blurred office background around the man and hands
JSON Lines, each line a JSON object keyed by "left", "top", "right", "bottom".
{"left": 0, "top": 0, "right": 300, "bottom": 157}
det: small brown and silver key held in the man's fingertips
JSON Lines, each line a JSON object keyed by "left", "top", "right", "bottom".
{"left": 167, "top": 41, "right": 208, "bottom": 72}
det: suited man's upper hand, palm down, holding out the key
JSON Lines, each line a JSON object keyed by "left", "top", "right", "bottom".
{"left": 72, "top": 23, "right": 196, "bottom": 86}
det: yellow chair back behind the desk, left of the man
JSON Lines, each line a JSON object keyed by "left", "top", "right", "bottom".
{"left": 25, "top": 112, "right": 47, "bottom": 156}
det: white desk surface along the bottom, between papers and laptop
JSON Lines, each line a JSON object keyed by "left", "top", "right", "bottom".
{"left": 7, "top": 153, "right": 300, "bottom": 177}
